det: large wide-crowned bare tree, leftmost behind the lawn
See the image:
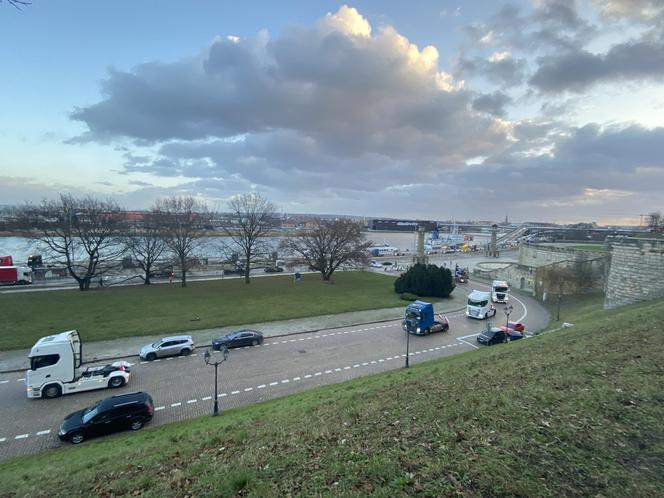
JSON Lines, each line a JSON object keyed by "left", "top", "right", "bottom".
{"left": 20, "top": 194, "right": 124, "bottom": 291}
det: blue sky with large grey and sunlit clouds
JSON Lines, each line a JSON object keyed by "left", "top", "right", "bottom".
{"left": 0, "top": 0, "right": 664, "bottom": 224}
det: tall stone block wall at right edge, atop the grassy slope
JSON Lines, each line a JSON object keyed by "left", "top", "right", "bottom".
{"left": 604, "top": 237, "right": 664, "bottom": 309}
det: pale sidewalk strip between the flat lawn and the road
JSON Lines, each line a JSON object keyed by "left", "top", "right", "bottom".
{"left": 0, "top": 294, "right": 472, "bottom": 373}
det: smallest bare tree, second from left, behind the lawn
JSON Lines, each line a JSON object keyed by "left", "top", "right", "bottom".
{"left": 124, "top": 208, "right": 167, "bottom": 285}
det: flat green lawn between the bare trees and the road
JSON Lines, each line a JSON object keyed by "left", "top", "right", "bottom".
{"left": 0, "top": 272, "right": 404, "bottom": 350}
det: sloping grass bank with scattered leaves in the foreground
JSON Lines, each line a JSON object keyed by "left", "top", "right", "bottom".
{"left": 0, "top": 300, "right": 664, "bottom": 497}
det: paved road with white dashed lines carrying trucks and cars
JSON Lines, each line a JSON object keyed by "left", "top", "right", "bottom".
{"left": 0, "top": 296, "right": 548, "bottom": 459}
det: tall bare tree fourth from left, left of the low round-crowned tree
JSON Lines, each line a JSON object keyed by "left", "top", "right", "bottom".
{"left": 222, "top": 193, "right": 277, "bottom": 284}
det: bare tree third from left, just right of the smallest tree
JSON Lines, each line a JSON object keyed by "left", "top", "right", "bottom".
{"left": 153, "top": 196, "right": 210, "bottom": 287}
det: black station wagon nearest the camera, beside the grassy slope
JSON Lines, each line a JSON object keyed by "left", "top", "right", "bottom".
{"left": 58, "top": 392, "right": 154, "bottom": 444}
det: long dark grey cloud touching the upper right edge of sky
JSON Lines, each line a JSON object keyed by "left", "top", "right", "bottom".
{"left": 530, "top": 40, "right": 664, "bottom": 93}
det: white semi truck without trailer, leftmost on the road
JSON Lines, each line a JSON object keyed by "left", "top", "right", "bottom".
{"left": 25, "top": 330, "right": 131, "bottom": 398}
